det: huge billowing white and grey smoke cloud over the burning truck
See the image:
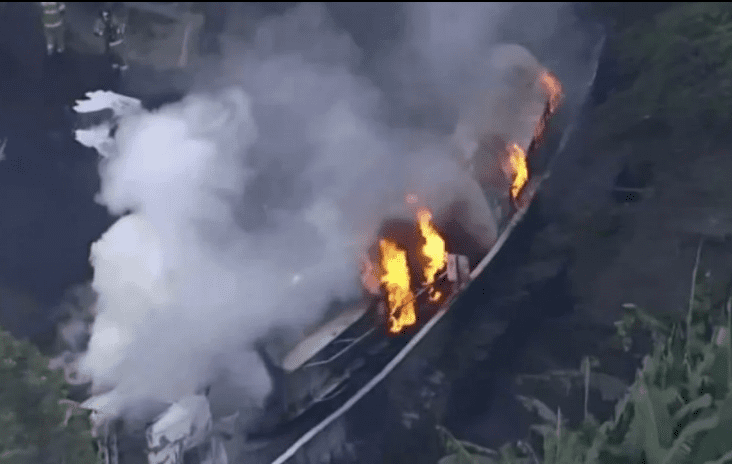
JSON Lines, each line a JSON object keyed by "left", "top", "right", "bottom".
{"left": 81, "top": 4, "right": 596, "bottom": 424}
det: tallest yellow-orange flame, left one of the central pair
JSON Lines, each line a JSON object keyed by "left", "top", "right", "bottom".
{"left": 379, "top": 239, "right": 417, "bottom": 333}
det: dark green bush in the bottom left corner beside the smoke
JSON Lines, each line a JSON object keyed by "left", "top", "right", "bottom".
{"left": 0, "top": 330, "right": 98, "bottom": 464}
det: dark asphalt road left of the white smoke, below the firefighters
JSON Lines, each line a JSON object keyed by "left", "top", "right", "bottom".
{"left": 0, "top": 2, "right": 189, "bottom": 348}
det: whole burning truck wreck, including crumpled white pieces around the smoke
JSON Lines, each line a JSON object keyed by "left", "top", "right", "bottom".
{"left": 66, "top": 51, "right": 563, "bottom": 464}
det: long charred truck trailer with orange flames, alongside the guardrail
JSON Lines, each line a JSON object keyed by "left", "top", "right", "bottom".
{"left": 250, "top": 61, "right": 563, "bottom": 446}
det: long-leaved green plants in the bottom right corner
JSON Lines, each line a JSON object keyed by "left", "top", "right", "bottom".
{"left": 440, "top": 268, "right": 732, "bottom": 464}
